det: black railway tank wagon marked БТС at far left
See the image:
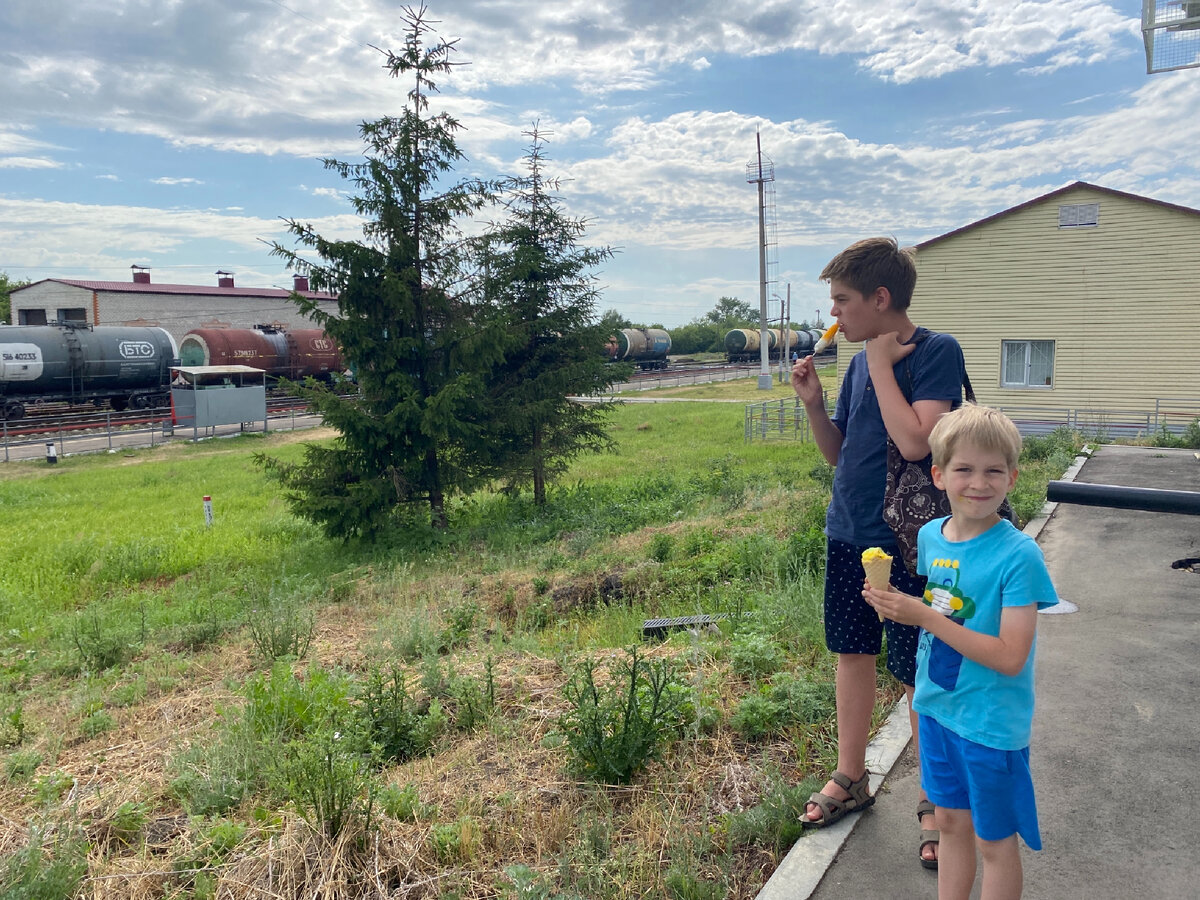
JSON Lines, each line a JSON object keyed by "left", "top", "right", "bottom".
{"left": 0, "top": 324, "right": 179, "bottom": 420}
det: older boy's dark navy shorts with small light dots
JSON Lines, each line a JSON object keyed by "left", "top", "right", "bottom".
{"left": 824, "top": 538, "right": 925, "bottom": 686}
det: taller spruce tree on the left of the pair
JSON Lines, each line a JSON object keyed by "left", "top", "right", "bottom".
{"left": 259, "top": 7, "right": 502, "bottom": 539}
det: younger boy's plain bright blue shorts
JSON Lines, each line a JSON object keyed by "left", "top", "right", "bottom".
{"left": 917, "top": 715, "right": 1042, "bottom": 850}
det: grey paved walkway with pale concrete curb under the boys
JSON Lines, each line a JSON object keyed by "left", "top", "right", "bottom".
{"left": 760, "top": 445, "right": 1200, "bottom": 900}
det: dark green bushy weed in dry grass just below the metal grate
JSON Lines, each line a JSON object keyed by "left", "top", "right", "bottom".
{"left": 559, "top": 647, "right": 684, "bottom": 784}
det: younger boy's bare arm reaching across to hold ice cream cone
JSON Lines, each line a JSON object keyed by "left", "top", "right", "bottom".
{"left": 863, "top": 587, "right": 1038, "bottom": 676}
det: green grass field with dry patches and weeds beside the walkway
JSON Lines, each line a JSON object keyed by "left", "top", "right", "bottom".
{"left": 0, "top": 379, "right": 1069, "bottom": 900}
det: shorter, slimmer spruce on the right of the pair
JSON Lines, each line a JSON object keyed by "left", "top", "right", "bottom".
{"left": 478, "top": 125, "right": 628, "bottom": 504}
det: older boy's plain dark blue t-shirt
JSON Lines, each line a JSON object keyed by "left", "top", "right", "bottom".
{"left": 826, "top": 329, "right": 966, "bottom": 547}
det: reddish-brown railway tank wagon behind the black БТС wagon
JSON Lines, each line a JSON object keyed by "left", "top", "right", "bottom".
{"left": 179, "top": 325, "right": 343, "bottom": 380}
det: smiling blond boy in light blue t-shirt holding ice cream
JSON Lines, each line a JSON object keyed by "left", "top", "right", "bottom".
{"left": 863, "top": 406, "right": 1057, "bottom": 900}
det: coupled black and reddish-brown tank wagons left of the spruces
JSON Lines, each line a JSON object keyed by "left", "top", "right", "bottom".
{"left": 0, "top": 323, "right": 343, "bottom": 420}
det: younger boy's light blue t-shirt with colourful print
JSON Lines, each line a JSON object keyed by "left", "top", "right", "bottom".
{"left": 912, "top": 518, "right": 1058, "bottom": 750}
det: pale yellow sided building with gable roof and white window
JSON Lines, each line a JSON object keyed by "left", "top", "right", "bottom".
{"left": 838, "top": 181, "right": 1200, "bottom": 436}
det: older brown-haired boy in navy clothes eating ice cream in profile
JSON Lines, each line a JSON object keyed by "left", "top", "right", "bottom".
{"left": 792, "top": 238, "right": 965, "bottom": 868}
